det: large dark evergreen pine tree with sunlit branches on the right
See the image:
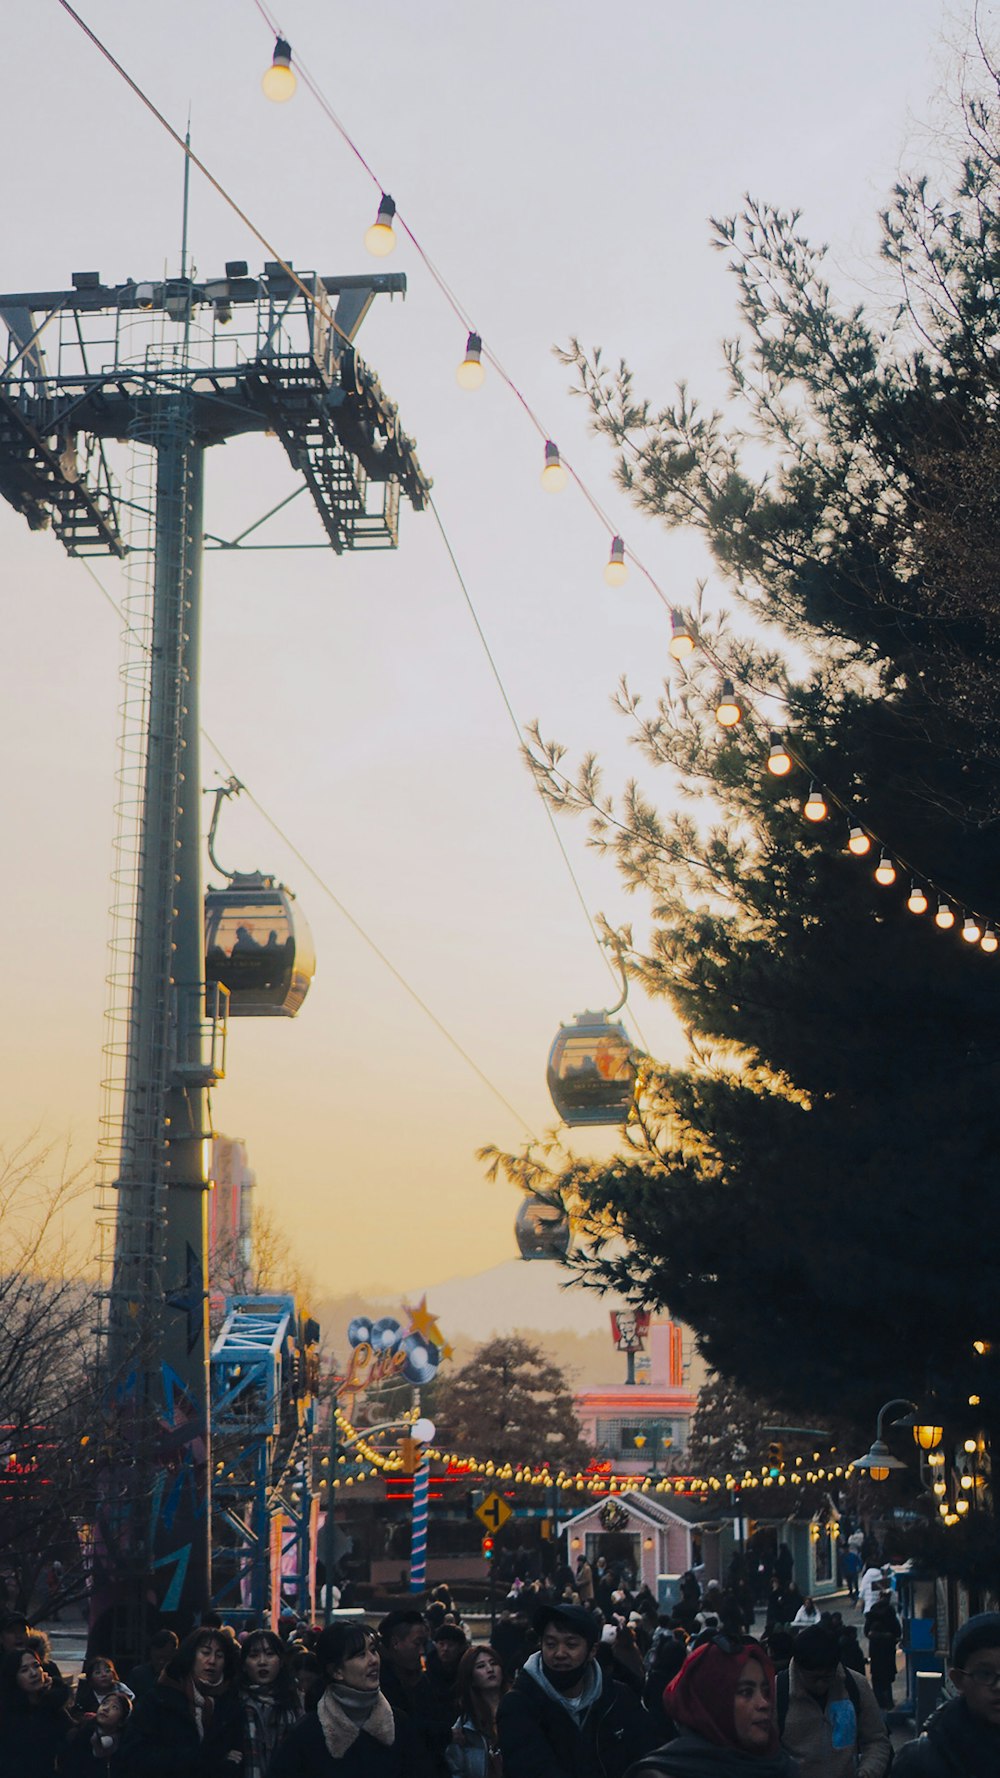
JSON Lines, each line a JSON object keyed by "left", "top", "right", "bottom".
{"left": 488, "top": 62, "right": 1000, "bottom": 1419}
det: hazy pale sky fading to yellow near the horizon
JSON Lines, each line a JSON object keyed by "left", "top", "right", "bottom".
{"left": 0, "top": 0, "right": 975, "bottom": 1296}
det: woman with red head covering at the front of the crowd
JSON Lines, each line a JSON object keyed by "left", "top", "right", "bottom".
{"left": 626, "top": 1636, "right": 795, "bottom": 1778}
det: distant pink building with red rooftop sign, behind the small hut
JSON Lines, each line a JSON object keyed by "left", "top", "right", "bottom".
{"left": 573, "top": 1317, "right": 698, "bottom": 1476}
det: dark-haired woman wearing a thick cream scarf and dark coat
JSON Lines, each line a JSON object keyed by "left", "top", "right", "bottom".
{"left": 267, "top": 1622, "right": 414, "bottom": 1778}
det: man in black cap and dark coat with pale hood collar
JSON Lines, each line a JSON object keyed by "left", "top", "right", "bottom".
{"left": 496, "top": 1602, "right": 658, "bottom": 1778}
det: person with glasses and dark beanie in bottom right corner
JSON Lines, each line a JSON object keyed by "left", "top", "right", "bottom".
{"left": 893, "top": 1611, "right": 1000, "bottom": 1778}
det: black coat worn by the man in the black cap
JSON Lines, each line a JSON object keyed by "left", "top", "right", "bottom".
{"left": 496, "top": 1649, "right": 658, "bottom": 1778}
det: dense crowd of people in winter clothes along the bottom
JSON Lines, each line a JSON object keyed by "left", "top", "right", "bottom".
{"left": 0, "top": 1563, "right": 1000, "bottom": 1778}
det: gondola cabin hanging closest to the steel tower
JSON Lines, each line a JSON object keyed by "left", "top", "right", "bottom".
{"left": 205, "top": 871, "right": 317, "bottom": 1019}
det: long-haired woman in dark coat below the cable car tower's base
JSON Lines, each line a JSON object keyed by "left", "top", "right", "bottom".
{"left": 121, "top": 1629, "right": 242, "bottom": 1778}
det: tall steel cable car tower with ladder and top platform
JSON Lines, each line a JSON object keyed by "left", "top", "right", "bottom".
{"left": 0, "top": 254, "right": 429, "bottom": 1659}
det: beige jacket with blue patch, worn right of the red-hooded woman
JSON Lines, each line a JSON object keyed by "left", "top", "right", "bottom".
{"left": 778, "top": 1661, "right": 891, "bottom": 1778}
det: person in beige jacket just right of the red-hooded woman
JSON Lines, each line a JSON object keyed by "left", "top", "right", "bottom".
{"left": 778, "top": 1625, "right": 891, "bottom": 1778}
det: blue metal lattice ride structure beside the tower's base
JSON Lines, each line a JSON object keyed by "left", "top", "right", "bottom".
{"left": 212, "top": 1294, "right": 320, "bottom": 1625}
